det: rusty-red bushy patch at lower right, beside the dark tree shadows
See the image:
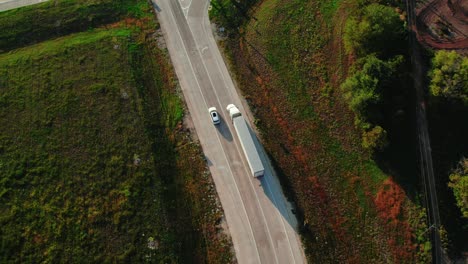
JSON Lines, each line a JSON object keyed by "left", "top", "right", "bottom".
{"left": 374, "top": 178, "right": 417, "bottom": 263}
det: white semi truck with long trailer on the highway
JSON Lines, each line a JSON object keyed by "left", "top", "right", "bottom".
{"left": 226, "top": 104, "right": 265, "bottom": 177}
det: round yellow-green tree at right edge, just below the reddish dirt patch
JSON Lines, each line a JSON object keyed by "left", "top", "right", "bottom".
{"left": 429, "top": 50, "right": 468, "bottom": 104}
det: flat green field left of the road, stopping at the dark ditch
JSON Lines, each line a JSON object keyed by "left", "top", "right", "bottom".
{"left": 0, "top": 29, "right": 180, "bottom": 263}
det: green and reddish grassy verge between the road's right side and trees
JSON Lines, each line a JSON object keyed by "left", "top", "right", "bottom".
{"left": 214, "top": 0, "right": 430, "bottom": 263}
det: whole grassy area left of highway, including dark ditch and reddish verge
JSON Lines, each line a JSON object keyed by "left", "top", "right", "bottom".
{"left": 0, "top": 1, "right": 230, "bottom": 263}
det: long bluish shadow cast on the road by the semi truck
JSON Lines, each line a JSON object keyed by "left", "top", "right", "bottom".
{"left": 247, "top": 123, "right": 299, "bottom": 231}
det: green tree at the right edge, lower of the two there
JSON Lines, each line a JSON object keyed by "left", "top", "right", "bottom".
{"left": 448, "top": 158, "right": 468, "bottom": 218}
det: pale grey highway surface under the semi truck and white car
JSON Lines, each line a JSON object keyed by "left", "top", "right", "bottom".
{"left": 153, "top": 0, "right": 306, "bottom": 264}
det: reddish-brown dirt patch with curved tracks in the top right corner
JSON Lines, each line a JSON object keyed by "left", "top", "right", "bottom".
{"left": 416, "top": 0, "right": 468, "bottom": 49}
